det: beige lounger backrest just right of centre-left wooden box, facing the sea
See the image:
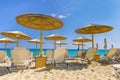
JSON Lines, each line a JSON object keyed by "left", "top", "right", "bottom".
{"left": 54, "top": 48, "right": 68, "bottom": 63}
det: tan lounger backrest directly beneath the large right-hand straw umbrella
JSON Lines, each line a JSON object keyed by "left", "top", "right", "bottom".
{"left": 85, "top": 48, "right": 98, "bottom": 60}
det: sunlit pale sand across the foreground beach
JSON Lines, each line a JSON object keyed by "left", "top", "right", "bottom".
{"left": 0, "top": 62, "right": 119, "bottom": 80}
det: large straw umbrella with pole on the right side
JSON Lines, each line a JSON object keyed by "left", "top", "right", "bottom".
{"left": 75, "top": 24, "right": 113, "bottom": 48}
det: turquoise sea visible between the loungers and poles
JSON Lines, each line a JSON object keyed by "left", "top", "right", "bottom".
{"left": 0, "top": 49, "right": 109, "bottom": 58}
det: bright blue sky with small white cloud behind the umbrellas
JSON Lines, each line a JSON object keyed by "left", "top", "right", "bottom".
{"left": 0, "top": 0, "right": 120, "bottom": 49}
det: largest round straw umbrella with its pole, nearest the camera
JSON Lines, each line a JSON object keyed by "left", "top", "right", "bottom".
{"left": 16, "top": 14, "right": 63, "bottom": 56}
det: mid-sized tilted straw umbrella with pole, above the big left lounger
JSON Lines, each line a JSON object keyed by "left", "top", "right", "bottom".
{"left": 1, "top": 31, "right": 31, "bottom": 47}
